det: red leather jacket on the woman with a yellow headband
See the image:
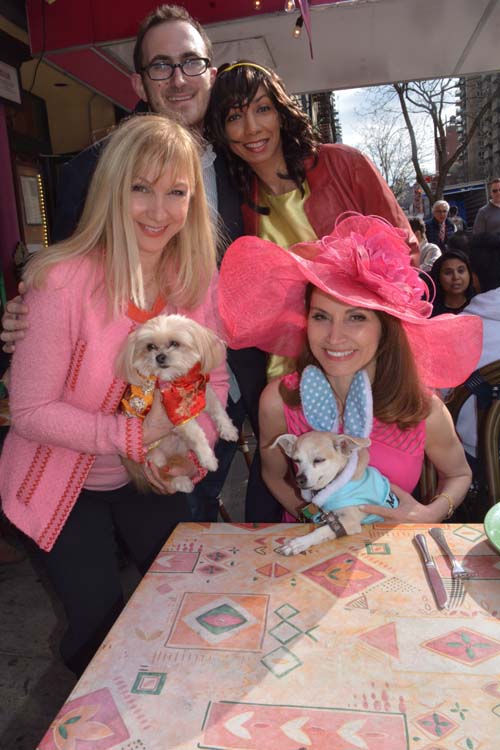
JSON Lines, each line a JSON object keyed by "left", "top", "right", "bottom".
{"left": 241, "top": 143, "right": 420, "bottom": 266}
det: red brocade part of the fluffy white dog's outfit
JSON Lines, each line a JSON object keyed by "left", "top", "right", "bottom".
{"left": 158, "top": 362, "right": 210, "bottom": 427}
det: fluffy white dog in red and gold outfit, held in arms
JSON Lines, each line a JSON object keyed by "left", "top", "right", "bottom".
{"left": 116, "top": 315, "right": 238, "bottom": 492}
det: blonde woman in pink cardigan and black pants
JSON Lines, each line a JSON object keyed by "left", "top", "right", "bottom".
{"left": 0, "top": 115, "right": 227, "bottom": 674}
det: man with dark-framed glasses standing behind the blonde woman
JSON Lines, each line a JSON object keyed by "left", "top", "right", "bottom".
{"left": 52, "top": 5, "right": 242, "bottom": 253}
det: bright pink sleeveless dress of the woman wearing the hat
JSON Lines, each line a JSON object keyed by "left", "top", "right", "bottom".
{"left": 282, "top": 372, "right": 425, "bottom": 523}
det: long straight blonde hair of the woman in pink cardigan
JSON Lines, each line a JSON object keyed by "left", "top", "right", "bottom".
{"left": 24, "top": 114, "right": 216, "bottom": 315}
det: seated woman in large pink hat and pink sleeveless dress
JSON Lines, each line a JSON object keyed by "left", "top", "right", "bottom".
{"left": 219, "top": 217, "right": 481, "bottom": 523}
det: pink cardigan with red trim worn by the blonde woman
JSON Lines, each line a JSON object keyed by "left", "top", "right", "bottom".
{"left": 0, "top": 258, "right": 228, "bottom": 551}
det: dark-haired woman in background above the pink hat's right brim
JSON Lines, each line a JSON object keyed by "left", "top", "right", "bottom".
{"left": 430, "top": 250, "right": 475, "bottom": 317}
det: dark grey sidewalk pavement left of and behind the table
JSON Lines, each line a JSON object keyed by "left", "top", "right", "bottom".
{"left": 0, "top": 452, "right": 248, "bottom": 750}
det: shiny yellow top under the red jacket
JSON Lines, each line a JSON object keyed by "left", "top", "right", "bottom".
{"left": 258, "top": 180, "right": 318, "bottom": 380}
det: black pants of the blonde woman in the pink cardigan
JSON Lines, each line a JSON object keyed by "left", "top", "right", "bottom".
{"left": 41, "top": 484, "right": 191, "bottom": 675}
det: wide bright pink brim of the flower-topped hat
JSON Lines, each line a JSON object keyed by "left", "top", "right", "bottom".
{"left": 219, "top": 237, "right": 482, "bottom": 388}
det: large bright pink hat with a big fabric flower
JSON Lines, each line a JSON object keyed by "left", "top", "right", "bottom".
{"left": 219, "top": 214, "right": 482, "bottom": 388}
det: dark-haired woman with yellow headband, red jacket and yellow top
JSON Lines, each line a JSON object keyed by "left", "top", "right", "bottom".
{"left": 205, "top": 60, "right": 418, "bottom": 261}
